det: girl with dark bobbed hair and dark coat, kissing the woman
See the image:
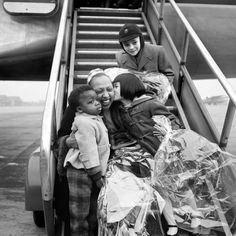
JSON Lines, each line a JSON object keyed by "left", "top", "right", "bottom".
{"left": 113, "top": 73, "right": 181, "bottom": 235}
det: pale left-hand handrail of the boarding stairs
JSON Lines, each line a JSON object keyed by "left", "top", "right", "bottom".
{"left": 40, "top": 0, "right": 72, "bottom": 204}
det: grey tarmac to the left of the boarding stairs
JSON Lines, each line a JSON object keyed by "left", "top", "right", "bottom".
{"left": 0, "top": 108, "right": 46, "bottom": 236}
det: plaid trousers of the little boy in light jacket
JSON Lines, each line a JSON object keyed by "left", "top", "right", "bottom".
{"left": 67, "top": 166, "right": 92, "bottom": 236}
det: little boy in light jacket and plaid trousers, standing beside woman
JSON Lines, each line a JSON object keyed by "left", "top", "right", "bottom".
{"left": 64, "top": 85, "right": 110, "bottom": 236}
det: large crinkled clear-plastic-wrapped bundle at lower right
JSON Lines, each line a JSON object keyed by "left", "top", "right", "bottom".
{"left": 152, "top": 117, "right": 236, "bottom": 234}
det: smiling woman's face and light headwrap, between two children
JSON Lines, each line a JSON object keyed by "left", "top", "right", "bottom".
{"left": 90, "top": 74, "right": 114, "bottom": 109}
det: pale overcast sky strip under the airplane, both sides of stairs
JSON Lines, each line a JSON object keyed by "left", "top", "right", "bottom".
{"left": 0, "top": 79, "right": 236, "bottom": 102}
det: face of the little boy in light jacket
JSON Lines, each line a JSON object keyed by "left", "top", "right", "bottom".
{"left": 77, "top": 90, "right": 102, "bottom": 115}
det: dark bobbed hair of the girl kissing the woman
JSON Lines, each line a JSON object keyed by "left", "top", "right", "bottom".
{"left": 113, "top": 73, "right": 146, "bottom": 100}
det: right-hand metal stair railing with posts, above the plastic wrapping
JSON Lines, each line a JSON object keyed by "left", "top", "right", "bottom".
{"left": 149, "top": 0, "right": 236, "bottom": 148}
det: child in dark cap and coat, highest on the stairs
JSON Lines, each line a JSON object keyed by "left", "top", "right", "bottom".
{"left": 116, "top": 24, "right": 174, "bottom": 84}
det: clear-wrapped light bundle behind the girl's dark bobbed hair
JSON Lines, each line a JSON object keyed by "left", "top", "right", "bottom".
{"left": 105, "top": 67, "right": 171, "bottom": 104}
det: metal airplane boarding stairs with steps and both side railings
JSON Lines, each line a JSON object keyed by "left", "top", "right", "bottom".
{"left": 26, "top": 0, "right": 236, "bottom": 236}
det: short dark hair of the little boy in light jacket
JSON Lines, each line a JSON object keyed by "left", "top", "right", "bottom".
{"left": 68, "top": 85, "right": 93, "bottom": 111}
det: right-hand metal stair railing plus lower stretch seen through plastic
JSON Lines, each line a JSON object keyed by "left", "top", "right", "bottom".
{"left": 148, "top": 0, "right": 236, "bottom": 236}
